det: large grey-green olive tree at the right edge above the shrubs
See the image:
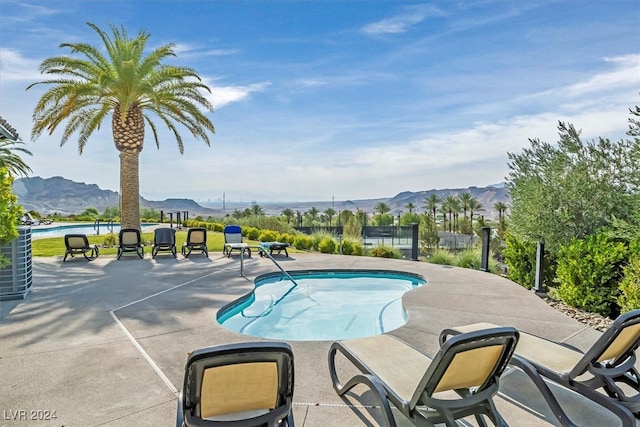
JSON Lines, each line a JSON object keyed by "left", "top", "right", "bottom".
{"left": 507, "top": 122, "right": 640, "bottom": 252}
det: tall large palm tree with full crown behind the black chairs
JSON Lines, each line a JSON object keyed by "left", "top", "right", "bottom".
{"left": 27, "top": 23, "right": 215, "bottom": 229}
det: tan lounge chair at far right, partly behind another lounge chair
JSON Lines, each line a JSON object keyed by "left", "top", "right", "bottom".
{"left": 441, "top": 310, "right": 640, "bottom": 427}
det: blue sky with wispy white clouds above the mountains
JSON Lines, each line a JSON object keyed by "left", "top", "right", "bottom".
{"left": 0, "top": 0, "right": 640, "bottom": 202}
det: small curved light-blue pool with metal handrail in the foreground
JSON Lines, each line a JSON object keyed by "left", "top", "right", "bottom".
{"left": 217, "top": 270, "right": 426, "bottom": 341}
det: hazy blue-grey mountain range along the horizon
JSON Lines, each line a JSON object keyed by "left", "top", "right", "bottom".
{"left": 13, "top": 176, "right": 509, "bottom": 218}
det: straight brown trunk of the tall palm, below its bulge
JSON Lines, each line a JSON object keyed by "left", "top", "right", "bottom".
{"left": 120, "top": 150, "right": 140, "bottom": 230}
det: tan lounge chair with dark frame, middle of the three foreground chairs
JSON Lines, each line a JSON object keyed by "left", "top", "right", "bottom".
{"left": 329, "top": 328, "right": 518, "bottom": 426}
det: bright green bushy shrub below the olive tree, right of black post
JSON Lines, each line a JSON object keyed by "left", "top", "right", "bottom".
{"left": 556, "top": 233, "right": 627, "bottom": 316}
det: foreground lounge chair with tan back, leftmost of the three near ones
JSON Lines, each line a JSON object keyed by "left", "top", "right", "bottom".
{"left": 176, "top": 342, "right": 294, "bottom": 427}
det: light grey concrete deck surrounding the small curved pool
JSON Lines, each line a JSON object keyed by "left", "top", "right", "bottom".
{"left": 0, "top": 252, "right": 632, "bottom": 427}
